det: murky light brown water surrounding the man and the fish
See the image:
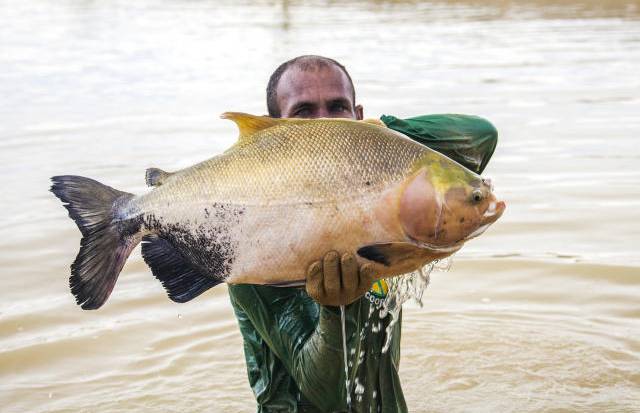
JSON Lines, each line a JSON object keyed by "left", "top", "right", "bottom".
{"left": 0, "top": 0, "right": 640, "bottom": 413}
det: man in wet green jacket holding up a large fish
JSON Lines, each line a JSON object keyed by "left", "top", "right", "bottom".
{"left": 229, "top": 56, "right": 497, "bottom": 412}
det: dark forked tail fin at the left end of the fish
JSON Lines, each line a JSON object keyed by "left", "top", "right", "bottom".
{"left": 50, "top": 175, "right": 140, "bottom": 310}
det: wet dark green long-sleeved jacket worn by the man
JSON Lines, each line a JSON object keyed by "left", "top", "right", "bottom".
{"left": 229, "top": 115, "right": 497, "bottom": 413}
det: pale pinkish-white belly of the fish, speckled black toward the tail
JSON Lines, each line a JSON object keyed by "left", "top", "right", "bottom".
{"left": 131, "top": 174, "right": 403, "bottom": 284}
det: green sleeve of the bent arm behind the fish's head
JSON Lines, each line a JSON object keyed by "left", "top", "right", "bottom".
{"left": 380, "top": 114, "right": 498, "bottom": 173}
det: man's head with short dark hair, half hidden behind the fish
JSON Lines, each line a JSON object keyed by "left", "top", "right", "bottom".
{"left": 267, "top": 55, "right": 362, "bottom": 119}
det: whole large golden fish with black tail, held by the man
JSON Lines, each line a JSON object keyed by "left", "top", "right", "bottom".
{"left": 51, "top": 113, "right": 505, "bottom": 309}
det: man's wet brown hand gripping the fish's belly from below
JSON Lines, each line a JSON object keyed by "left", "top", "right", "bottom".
{"left": 306, "top": 251, "right": 375, "bottom": 306}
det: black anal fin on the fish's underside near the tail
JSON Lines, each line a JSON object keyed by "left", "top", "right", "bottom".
{"left": 142, "top": 235, "right": 222, "bottom": 303}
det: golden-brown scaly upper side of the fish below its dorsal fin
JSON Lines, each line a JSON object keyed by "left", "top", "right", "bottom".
{"left": 139, "top": 120, "right": 424, "bottom": 208}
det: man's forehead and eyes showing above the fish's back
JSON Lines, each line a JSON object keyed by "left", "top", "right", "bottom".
{"left": 276, "top": 65, "right": 362, "bottom": 119}
